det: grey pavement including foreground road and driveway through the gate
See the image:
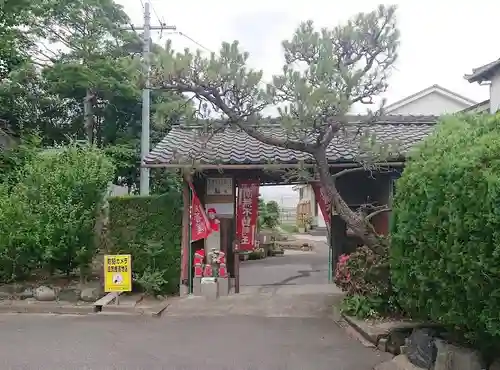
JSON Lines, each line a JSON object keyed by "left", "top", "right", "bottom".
{"left": 0, "top": 236, "right": 388, "bottom": 370}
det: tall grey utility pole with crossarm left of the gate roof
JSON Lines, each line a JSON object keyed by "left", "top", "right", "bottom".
{"left": 124, "top": 0, "right": 176, "bottom": 195}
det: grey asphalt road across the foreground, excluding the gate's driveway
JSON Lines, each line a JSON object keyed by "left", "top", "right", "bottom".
{"left": 0, "top": 314, "right": 387, "bottom": 370}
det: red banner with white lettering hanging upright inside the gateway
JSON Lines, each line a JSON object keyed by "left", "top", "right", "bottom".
{"left": 236, "top": 180, "right": 260, "bottom": 251}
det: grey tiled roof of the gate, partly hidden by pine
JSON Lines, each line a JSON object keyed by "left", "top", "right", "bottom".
{"left": 144, "top": 115, "right": 437, "bottom": 165}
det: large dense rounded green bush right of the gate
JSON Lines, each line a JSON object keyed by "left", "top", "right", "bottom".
{"left": 391, "top": 115, "right": 500, "bottom": 346}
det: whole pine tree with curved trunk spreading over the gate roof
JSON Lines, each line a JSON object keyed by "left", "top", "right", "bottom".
{"left": 152, "top": 5, "right": 399, "bottom": 249}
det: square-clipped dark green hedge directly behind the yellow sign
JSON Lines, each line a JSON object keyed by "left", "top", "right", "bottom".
{"left": 107, "top": 192, "right": 182, "bottom": 295}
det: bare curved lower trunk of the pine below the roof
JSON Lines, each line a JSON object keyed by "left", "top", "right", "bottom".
{"left": 314, "top": 150, "right": 383, "bottom": 254}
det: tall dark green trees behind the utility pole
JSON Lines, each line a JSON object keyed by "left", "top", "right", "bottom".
{"left": 0, "top": 0, "right": 192, "bottom": 191}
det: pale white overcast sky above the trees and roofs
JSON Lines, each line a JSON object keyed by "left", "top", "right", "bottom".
{"left": 117, "top": 0, "right": 500, "bottom": 203}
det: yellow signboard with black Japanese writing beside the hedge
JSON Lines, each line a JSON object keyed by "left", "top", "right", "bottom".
{"left": 104, "top": 254, "right": 132, "bottom": 292}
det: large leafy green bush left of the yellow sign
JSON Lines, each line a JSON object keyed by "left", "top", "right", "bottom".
{"left": 0, "top": 144, "right": 114, "bottom": 281}
